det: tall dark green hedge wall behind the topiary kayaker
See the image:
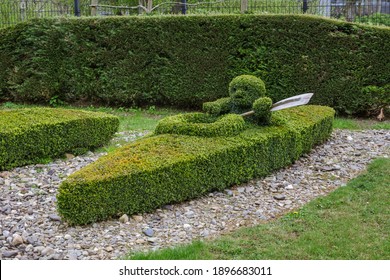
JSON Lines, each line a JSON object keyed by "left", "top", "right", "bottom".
{"left": 0, "top": 15, "right": 390, "bottom": 114}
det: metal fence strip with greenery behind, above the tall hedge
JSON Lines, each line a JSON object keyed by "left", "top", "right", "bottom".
{"left": 0, "top": 0, "right": 390, "bottom": 27}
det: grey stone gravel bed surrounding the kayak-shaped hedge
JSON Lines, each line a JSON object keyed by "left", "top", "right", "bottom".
{"left": 0, "top": 130, "right": 390, "bottom": 260}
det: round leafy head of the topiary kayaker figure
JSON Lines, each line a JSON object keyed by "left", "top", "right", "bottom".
{"left": 229, "top": 75, "right": 265, "bottom": 108}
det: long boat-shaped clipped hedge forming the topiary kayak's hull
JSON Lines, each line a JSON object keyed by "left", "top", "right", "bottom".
{"left": 57, "top": 106, "right": 334, "bottom": 224}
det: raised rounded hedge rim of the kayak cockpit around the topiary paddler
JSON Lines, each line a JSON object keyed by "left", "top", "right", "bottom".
{"left": 154, "top": 113, "right": 246, "bottom": 137}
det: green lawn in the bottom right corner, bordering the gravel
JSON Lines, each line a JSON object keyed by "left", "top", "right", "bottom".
{"left": 125, "top": 159, "right": 390, "bottom": 260}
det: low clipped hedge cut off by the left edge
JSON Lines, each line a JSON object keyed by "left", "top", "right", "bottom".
{"left": 0, "top": 108, "right": 119, "bottom": 170}
